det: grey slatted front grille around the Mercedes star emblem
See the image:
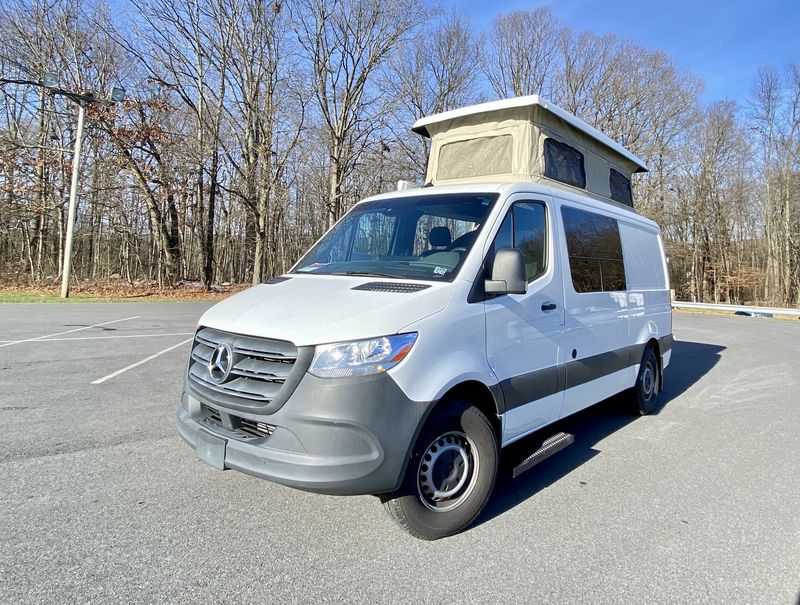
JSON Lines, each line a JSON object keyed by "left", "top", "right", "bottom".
{"left": 189, "top": 328, "right": 297, "bottom": 407}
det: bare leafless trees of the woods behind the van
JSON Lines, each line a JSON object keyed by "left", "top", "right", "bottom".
{"left": 0, "top": 0, "right": 800, "bottom": 306}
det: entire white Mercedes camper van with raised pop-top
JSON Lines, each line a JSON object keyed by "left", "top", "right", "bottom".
{"left": 177, "top": 96, "right": 672, "bottom": 539}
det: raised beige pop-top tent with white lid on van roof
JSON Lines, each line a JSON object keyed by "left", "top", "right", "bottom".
{"left": 412, "top": 95, "right": 647, "bottom": 207}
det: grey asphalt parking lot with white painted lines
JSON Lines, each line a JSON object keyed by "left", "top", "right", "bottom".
{"left": 0, "top": 303, "right": 800, "bottom": 603}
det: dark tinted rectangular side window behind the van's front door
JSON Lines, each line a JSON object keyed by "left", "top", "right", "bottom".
{"left": 561, "top": 206, "right": 627, "bottom": 292}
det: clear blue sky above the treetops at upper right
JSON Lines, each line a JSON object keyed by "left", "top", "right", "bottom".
{"left": 456, "top": 0, "right": 800, "bottom": 103}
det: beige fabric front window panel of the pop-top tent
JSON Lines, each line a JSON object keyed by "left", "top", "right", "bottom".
{"left": 436, "top": 134, "right": 514, "bottom": 180}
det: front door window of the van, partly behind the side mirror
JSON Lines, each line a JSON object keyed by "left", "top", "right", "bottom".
{"left": 487, "top": 202, "right": 547, "bottom": 281}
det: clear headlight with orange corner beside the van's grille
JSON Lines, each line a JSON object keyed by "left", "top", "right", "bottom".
{"left": 308, "top": 332, "right": 417, "bottom": 378}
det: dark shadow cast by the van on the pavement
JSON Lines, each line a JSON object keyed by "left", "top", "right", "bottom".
{"left": 476, "top": 340, "right": 725, "bottom": 525}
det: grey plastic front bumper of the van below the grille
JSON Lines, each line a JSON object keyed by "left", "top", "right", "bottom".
{"left": 177, "top": 374, "right": 431, "bottom": 495}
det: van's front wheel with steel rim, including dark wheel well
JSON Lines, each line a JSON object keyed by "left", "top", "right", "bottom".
{"left": 381, "top": 401, "right": 499, "bottom": 540}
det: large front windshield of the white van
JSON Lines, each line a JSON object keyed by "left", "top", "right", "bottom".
{"left": 293, "top": 193, "right": 498, "bottom": 281}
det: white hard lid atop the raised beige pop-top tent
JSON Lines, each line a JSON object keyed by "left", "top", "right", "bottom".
{"left": 411, "top": 95, "right": 647, "bottom": 172}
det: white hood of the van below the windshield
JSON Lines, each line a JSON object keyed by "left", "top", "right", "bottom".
{"left": 199, "top": 275, "right": 452, "bottom": 347}
